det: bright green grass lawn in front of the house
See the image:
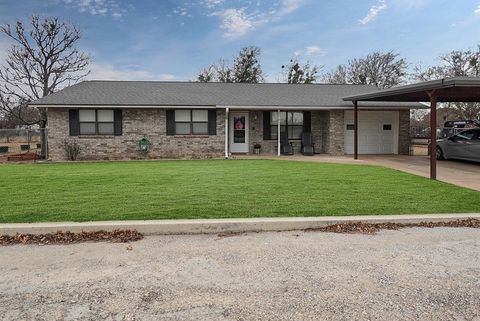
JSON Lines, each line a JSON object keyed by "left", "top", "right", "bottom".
{"left": 0, "top": 160, "right": 480, "bottom": 223}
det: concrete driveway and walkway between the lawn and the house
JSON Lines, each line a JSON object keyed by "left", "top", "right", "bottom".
{"left": 237, "top": 155, "right": 480, "bottom": 191}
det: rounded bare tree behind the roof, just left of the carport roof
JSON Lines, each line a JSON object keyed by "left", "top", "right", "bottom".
{"left": 323, "top": 51, "right": 408, "bottom": 88}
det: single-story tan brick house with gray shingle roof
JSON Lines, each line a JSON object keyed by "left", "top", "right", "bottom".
{"left": 30, "top": 81, "right": 423, "bottom": 160}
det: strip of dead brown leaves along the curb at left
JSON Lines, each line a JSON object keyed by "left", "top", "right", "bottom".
{"left": 0, "top": 230, "right": 143, "bottom": 245}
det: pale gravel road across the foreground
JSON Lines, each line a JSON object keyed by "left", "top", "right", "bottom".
{"left": 0, "top": 228, "right": 480, "bottom": 321}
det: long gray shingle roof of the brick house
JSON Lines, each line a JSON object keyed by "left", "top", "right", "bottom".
{"left": 31, "top": 80, "right": 420, "bottom": 108}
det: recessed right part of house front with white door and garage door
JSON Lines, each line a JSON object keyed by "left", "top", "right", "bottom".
{"left": 222, "top": 108, "right": 410, "bottom": 158}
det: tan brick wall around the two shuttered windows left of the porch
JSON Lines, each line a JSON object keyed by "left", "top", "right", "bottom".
{"left": 48, "top": 108, "right": 225, "bottom": 160}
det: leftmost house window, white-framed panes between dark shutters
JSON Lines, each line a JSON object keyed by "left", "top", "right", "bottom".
{"left": 78, "top": 109, "right": 114, "bottom": 135}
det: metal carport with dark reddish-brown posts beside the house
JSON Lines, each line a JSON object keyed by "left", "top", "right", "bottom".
{"left": 343, "top": 77, "right": 480, "bottom": 179}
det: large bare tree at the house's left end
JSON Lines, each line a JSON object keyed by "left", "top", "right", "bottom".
{"left": 0, "top": 15, "right": 90, "bottom": 156}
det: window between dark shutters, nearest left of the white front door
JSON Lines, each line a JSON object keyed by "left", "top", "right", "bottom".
{"left": 175, "top": 109, "right": 208, "bottom": 135}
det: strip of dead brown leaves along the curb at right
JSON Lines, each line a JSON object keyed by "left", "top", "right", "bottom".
{"left": 305, "top": 218, "right": 480, "bottom": 234}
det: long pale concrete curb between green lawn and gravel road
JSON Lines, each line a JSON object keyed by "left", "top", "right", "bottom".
{"left": 0, "top": 213, "right": 480, "bottom": 236}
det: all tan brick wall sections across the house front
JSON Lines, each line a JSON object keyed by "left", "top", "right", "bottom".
{"left": 48, "top": 108, "right": 410, "bottom": 160}
